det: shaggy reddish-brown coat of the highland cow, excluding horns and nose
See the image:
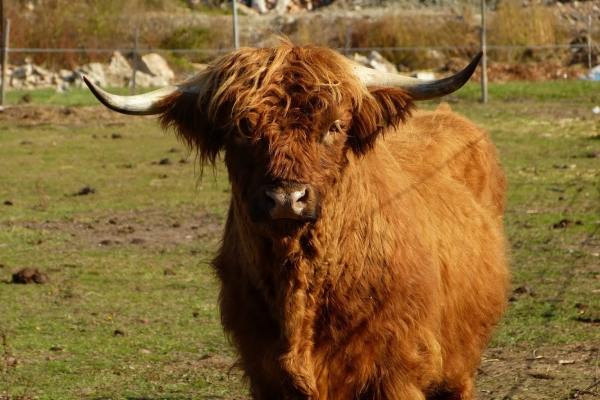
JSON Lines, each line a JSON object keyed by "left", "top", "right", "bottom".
{"left": 154, "top": 41, "right": 509, "bottom": 400}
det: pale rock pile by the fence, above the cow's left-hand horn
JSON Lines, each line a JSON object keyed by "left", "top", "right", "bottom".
{"left": 7, "top": 51, "right": 175, "bottom": 92}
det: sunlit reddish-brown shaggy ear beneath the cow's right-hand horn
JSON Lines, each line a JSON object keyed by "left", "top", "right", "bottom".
{"left": 348, "top": 87, "right": 414, "bottom": 154}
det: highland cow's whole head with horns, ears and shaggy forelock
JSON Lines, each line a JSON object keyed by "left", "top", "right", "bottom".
{"left": 86, "top": 41, "right": 481, "bottom": 236}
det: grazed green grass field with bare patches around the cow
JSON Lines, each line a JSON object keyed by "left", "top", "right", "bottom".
{"left": 0, "top": 81, "right": 600, "bottom": 400}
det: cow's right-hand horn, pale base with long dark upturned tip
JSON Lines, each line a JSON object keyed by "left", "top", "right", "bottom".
{"left": 353, "top": 52, "right": 483, "bottom": 100}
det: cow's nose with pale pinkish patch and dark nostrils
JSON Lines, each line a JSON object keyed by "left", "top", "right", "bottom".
{"left": 265, "top": 183, "right": 309, "bottom": 219}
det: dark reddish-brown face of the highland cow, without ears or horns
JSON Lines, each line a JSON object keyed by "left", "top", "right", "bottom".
{"left": 224, "top": 84, "right": 353, "bottom": 229}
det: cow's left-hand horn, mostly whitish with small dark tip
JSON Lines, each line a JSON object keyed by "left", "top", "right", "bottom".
{"left": 83, "top": 76, "right": 191, "bottom": 115}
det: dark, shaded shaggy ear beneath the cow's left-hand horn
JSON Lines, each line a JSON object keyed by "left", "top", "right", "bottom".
{"left": 159, "top": 92, "right": 224, "bottom": 166}
